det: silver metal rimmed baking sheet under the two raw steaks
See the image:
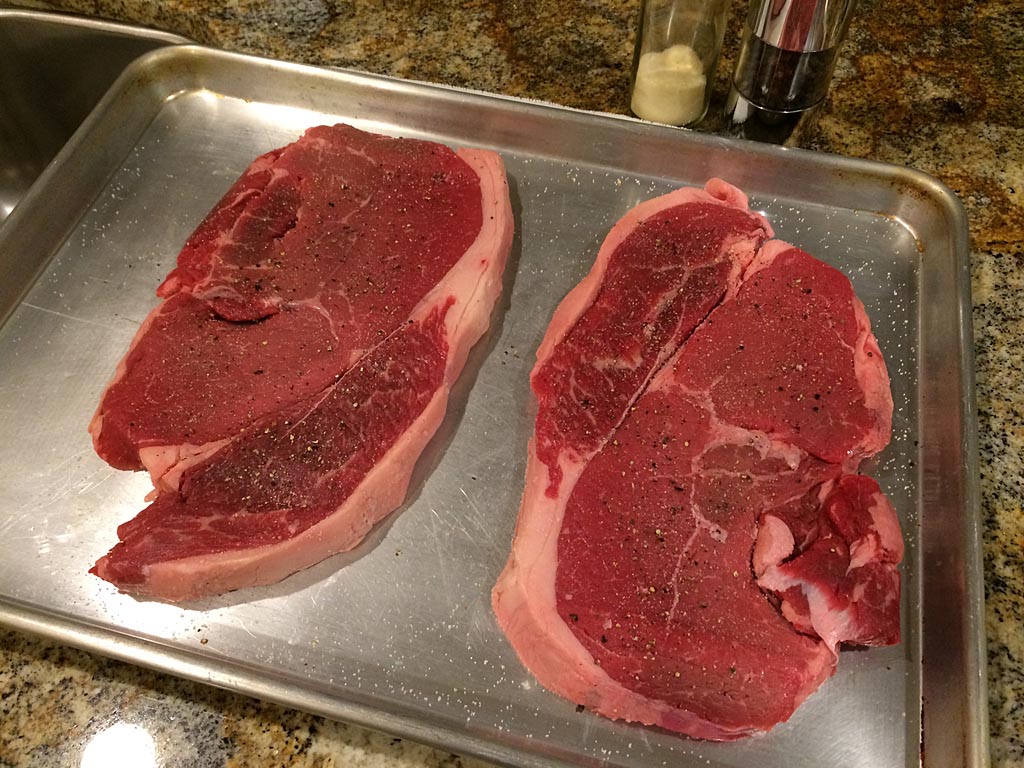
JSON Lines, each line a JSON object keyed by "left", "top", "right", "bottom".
{"left": 0, "top": 47, "right": 985, "bottom": 768}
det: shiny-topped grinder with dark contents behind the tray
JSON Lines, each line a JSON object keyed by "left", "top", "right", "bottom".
{"left": 726, "top": 0, "right": 855, "bottom": 142}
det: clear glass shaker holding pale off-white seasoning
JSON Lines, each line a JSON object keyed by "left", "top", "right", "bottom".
{"left": 630, "top": 0, "right": 728, "bottom": 125}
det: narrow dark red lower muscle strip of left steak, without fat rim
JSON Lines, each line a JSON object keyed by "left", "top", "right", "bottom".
{"left": 96, "top": 307, "right": 449, "bottom": 588}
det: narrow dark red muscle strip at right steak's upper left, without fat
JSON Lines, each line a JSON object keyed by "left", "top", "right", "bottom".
{"left": 531, "top": 202, "right": 766, "bottom": 495}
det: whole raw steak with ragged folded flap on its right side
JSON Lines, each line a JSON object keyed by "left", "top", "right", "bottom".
{"left": 493, "top": 180, "right": 902, "bottom": 739}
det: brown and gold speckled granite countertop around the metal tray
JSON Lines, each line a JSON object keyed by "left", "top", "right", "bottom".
{"left": 0, "top": 0, "right": 1024, "bottom": 768}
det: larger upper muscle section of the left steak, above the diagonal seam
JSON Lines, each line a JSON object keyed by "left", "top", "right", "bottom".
{"left": 89, "top": 125, "right": 497, "bottom": 488}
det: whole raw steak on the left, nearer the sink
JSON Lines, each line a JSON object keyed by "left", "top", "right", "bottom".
{"left": 93, "top": 126, "right": 512, "bottom": 600}
